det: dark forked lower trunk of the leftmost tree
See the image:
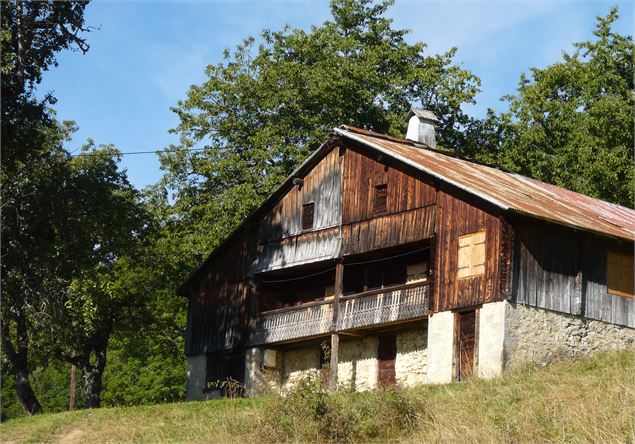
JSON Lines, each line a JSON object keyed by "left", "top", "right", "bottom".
{"left": 0, "top": 313, "right": 42, "bottom": 415}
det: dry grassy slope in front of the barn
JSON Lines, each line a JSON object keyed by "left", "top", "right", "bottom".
{"left": 0, "top": 352, "right": 635, "bottom": 442}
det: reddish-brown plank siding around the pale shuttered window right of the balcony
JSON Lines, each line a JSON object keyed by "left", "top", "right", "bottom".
{"left": 434, "top": 189, "right": 501, "bottom": 311}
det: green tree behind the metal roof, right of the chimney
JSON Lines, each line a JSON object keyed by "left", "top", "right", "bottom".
{"left": 478, "top": 7, "right": 635, "bottom": 206}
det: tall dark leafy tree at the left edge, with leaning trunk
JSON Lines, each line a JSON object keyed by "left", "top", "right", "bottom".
{"left": 0, "top": 1, "right": 88, "bottom": 414}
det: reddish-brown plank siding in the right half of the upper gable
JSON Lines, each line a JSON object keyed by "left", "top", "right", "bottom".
{"left": 342, "top": 149, "right": 436, "bottom": 224}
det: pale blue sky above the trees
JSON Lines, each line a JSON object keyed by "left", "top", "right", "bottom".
{"left": 40, "top": 0, "right": 634, "bottom": 188}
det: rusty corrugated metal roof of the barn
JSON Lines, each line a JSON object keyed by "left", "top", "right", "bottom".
{"left": 335, "top": 126, "right": 635, "bottom": 240}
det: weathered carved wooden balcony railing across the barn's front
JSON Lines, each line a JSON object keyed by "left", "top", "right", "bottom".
{"left": 248, "top": 283, "right": 430, "bottom": 345}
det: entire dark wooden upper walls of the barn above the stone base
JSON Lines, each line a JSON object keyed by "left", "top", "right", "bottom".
{"left": 181, "top": 134, "right": 635, "bottom": 355}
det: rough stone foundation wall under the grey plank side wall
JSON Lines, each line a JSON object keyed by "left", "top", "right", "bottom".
{"left": 503, "top": 303, "right": 635, "bottom": 370}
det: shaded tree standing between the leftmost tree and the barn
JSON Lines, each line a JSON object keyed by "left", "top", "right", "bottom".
{"left": 41, "top": 144, "right": 149, "bottom": 408}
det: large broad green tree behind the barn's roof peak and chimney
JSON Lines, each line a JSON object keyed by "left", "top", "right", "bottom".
{"left": 162, "top": 0, "right": 479, "bottom": 257}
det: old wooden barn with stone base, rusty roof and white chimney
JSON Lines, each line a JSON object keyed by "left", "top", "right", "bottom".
{"left": 179, "top": 110, "right": 635, "bottom": 399}
